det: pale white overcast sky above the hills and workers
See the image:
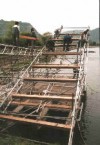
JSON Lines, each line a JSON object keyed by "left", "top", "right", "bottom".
{"left": 0, "top": 0, "right": 99, "bottom": 34}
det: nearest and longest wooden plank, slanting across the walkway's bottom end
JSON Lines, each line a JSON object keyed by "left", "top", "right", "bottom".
{"left": 0, "top": 114, "right": 71, "bottom": 130}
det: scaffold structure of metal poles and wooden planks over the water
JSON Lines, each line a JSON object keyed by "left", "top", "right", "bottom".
{"left": 0, "top": 27, "right": 89, "bottom": 145}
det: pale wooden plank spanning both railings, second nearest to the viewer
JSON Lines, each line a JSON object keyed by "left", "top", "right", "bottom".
{"left": 12, "top": 93, "right": 73, "bottom": 101}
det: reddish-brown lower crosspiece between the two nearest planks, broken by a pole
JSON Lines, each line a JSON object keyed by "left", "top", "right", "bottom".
{"left": 11, "top": 101, "right": 72, "bottom": 110}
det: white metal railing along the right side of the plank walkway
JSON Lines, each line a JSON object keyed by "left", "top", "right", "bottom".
{"left": 68, "top": 45, "right": 86, "bottom": 145}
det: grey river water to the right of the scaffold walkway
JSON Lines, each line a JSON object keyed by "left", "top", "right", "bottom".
{"left": 75, "top": 48, "right": 100, "bottom": 145}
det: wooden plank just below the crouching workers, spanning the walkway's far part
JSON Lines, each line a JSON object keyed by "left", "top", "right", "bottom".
{"left": 42, "top": 51, "right": 82, "bottom": 55}
